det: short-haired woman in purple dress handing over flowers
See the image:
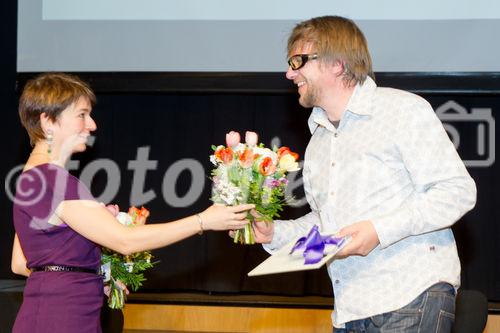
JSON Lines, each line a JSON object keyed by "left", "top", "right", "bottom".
{"left": 12, "top": 74, "right": 253, "bottom": 332}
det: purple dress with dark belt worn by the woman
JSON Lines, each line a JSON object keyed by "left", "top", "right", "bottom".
{"left": 13, "top": 164, "right": 103, "bottom": 333}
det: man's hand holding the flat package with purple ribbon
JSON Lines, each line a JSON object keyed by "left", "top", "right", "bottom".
{"left": 336, "top": 221, "right": 380, "bottom": 258}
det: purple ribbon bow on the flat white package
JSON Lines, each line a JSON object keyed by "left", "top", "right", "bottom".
{"left": 290, "top": 225, "right": 345, "bottom": 265}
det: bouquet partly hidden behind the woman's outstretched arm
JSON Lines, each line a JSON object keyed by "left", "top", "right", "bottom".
{"left": 101, "top": 205, "right": 155, "bottom": 309}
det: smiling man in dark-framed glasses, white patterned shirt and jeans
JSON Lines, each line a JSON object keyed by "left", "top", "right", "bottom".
{"left": 254, "top": 16, "right": 476, "bottom": 332}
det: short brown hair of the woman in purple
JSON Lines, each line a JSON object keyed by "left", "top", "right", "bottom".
{"left": 19, "top": 73, "right": 96, "bottom": 145}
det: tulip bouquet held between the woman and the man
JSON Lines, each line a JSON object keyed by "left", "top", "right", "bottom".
{"left": 210, "top": 131, "right": 300, "bottom": 244}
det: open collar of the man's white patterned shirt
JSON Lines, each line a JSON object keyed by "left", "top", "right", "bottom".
{"left": 308, "top": 76, "right": 377, "bottom": 133}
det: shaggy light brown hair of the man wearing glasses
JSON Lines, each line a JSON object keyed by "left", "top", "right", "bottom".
{"left": 288, "top": 16, "right": 374, "bottom": 85}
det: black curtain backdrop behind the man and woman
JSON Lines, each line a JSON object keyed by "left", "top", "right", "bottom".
{"left": 0, "top": 1, "right": 500, "bottom": 301}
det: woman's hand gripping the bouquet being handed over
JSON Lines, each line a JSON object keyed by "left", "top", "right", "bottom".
{"left": 200, "top": 204, "right": 255, "bottom": 230}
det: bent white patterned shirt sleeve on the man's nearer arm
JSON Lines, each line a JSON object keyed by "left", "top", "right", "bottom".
{"left": 371, "top": 98, "right": 476, "bottom": 247}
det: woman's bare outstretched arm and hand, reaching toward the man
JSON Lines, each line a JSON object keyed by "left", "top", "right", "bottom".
{"left": 56, "top": 200, "right": 254, "bottom": 255}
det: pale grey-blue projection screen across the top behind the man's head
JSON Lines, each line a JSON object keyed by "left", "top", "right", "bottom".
{"left": 17, "top": 0, "right": 500, "bottom": 72}
